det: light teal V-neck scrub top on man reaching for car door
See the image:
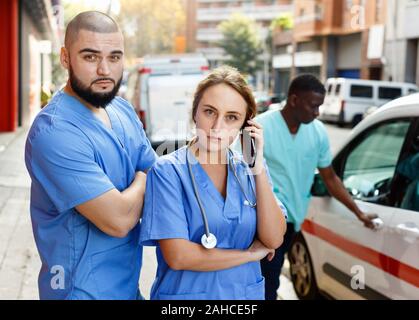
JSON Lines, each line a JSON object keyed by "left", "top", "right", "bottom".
{"left": 256, "top": 110, "right": 332, "bottom": 231}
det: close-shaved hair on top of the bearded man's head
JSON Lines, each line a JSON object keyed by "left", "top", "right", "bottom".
{"left": 64, "top": 11, "right": 121, "bottom": 49}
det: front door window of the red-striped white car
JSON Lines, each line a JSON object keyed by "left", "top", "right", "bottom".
{"left": 343, "top": 120, "right": 410, "bottom": 202}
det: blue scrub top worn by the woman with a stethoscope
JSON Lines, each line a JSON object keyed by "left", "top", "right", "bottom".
{"left": 140, "top": 147, "right": 288, "bottom": 300}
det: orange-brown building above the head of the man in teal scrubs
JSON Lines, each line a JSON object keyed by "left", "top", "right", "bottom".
{"left": 272, "top": 0, "right": 386, "bottom": 96}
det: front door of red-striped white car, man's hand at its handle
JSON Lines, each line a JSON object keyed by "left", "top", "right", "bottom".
{"left": 303, "top": 119, "right": 411, "bottom": 299}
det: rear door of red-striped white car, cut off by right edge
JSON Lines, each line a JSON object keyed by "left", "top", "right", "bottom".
{"left": 384, "top": 119, "right": 419, "bottom": 299}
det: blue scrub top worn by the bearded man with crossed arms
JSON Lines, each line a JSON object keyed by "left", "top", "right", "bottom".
{"left": 25, "top": 91, "right": 157, "bottom": 299}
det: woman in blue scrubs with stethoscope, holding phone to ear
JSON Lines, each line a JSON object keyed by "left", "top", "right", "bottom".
{"left": 140, "top": 67, "right": 286, "bottom": 300}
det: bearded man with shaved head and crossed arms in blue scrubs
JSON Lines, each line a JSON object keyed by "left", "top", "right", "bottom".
{"left": 25, "top": 11, "right": 156, "bottom": 299}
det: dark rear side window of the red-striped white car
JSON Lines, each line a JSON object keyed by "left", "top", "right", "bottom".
{"left": 395, "top": 128, "right": 419, "bottom": 212}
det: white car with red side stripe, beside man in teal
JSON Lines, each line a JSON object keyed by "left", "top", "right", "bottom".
{"left": 288, "top": 94, "right": 419, "bottom": 299}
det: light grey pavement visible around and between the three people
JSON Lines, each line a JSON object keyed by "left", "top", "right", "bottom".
{"left": 0, "top": 125, "right": 349, "bottom": 300}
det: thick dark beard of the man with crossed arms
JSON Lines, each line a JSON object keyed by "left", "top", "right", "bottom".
{"left": 69, "top": 66, "right": 122, "bottom": 108}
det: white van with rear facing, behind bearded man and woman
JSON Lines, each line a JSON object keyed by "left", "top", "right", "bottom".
{"left": 126, "top": 54, "right": 209, "bottom": 153}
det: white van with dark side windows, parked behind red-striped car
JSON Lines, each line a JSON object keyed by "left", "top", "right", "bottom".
{"left": 319, "top": 78, "right": 419, "bottom": 126}
